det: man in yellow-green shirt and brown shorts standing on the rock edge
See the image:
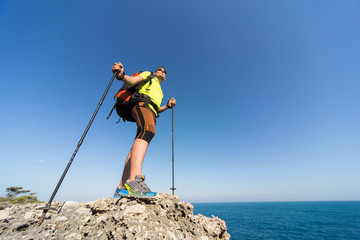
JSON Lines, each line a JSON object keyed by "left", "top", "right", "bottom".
{"left": 112, "top": 62, "right": 176, "bottom": 198}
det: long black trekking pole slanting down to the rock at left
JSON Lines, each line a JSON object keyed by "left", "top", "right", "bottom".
{"left": 37, "top": 72, "right": 117, "bottom": 226}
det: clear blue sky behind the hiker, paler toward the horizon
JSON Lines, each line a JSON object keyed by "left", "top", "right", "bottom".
{"left": 0, "top": 0, "right": 360, "bottom": 202}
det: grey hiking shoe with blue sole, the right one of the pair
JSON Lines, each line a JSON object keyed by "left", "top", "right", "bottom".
{"left": 124, "top": 175, "right": 157, "bottom": 197}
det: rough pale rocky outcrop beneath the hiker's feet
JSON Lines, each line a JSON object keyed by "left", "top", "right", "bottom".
{"left": 0, "top": 193, "right": 230, "bottom": 240}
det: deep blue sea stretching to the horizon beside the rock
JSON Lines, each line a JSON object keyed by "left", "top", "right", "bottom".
{"left": 193, "top": 201, "right": 360, "bottom": 240}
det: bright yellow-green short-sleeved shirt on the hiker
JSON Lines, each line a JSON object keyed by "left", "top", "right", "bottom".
{"left": 139, "top": 71, "right": 164, "bottom": 116}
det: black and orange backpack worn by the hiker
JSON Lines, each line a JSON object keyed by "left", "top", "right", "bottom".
{"left": 106, "top": 71, "right": 158, "bottom": 122}
